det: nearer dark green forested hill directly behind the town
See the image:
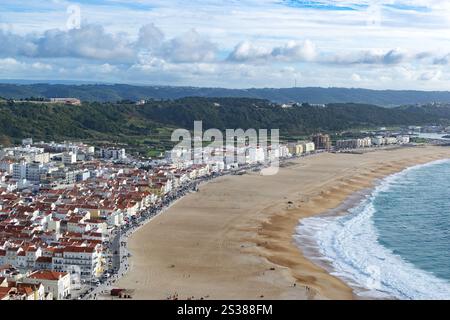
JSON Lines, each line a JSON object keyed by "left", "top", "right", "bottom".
{"left": 0, "top": 98, "right": 450, "bottom": 142}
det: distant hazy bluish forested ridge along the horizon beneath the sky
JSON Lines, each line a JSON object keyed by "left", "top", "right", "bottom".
{"left": 0, "top": 83, "right": 450, "bottom": 106}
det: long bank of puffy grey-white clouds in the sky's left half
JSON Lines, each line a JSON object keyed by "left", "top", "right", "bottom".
{"left": 0, "top": 24, "right": 221, "bottom": 63}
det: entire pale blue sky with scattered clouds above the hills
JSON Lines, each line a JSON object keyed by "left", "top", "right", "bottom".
{"left": 0, "top": 0, "right": 450, "bottom": 90}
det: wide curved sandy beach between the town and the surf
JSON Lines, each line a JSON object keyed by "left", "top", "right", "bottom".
{"left": 116, "top": 146, "right": 450, "bottom": 299}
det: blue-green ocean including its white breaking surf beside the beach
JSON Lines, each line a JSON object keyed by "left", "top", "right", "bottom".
{"left": 294, "top": 160, "right": 450, "bottom": 299}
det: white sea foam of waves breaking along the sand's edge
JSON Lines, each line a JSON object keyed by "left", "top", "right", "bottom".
{"left": 294, "top": 160, "right": 450, "bottom": 299}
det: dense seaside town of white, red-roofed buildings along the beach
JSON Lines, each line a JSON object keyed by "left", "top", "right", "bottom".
{"left": 0, "top": 128, "right": 428, "bottom": 300}
